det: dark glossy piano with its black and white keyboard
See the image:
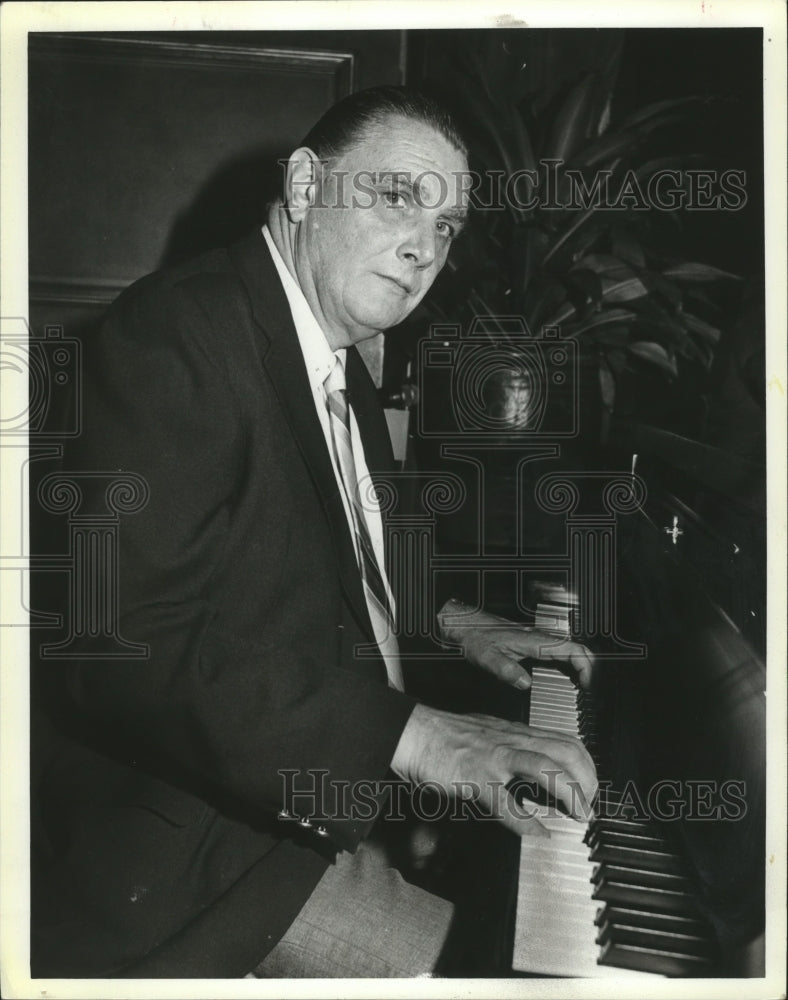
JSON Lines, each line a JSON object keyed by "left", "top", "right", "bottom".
{"left": 511, "top": 450, "right": 766, "bottom": 978}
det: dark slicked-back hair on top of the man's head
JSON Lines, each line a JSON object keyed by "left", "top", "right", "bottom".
{"left": 300, "top": 86, "right": 468, "bottom": 160}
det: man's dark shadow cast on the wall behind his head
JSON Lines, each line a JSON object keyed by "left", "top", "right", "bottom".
{"left": 159, "top": 149, "right": 290, "bottom": 267}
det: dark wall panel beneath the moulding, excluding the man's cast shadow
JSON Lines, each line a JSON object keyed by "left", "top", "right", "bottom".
{"left": 30, "top": 39, "right": 353, "bottom": 280}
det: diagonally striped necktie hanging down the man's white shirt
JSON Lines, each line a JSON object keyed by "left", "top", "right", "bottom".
{"left": 324, "top": 358, "right": 403, "bottom": 691}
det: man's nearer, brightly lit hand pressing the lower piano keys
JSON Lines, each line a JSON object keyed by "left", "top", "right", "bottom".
{"left": 391, "top": 705, "right": 597, "bottom": 836}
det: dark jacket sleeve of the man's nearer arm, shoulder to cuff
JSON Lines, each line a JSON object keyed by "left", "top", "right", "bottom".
{"left": 48, "top": 279, "right": 414, "bottom": 849}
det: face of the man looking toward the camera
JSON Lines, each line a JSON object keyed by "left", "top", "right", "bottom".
{"left": 294, "top": 116, "right": 468, "bottom": 348}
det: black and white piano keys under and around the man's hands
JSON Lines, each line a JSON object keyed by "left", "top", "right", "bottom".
{"left": 512, "top": 666, "right": 714, "bottom": 978}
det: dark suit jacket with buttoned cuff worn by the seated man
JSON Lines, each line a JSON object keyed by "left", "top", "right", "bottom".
{"left": 32, "top": 233, "right": 413, "bottom": 977}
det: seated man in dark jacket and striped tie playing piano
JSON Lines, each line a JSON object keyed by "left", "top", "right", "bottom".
{"left": 33, "top": 88, "right": 595, "bottom": 977}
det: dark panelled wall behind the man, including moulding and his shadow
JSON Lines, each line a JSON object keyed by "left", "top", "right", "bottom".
{"left": 28, "top": 31, "right": 403, "bottom": 382}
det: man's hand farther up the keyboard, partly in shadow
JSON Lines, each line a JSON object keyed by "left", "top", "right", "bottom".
{"left": 438, "top": 600, "right": 594, "bottom": 690}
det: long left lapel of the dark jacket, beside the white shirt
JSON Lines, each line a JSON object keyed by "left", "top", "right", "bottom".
{"left": 228, "top": 232, "right": 378, "bottom": 641}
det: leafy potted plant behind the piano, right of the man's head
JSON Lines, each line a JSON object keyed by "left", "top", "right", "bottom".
{"left": 410, "top": 32, "right": 740, "bottom": 444}
